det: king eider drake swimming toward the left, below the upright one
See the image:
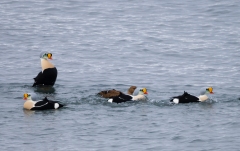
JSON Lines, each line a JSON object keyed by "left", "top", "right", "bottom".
{"left": 23, "top": 93, "right": 63, "bottom": 110}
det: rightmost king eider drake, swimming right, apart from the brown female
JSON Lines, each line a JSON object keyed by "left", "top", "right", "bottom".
{"left": 170, "top": 87, "right": 213, "bottom": 104}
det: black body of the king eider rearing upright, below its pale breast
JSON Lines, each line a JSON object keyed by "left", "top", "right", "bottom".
{"left": 33, "top": 67, "right": 57, "bottom": 87}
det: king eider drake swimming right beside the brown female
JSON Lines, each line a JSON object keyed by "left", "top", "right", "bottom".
{"left": 108, "top": 88, "right": 148, "bottom": 103}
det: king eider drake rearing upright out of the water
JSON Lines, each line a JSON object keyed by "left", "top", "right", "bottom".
{"left": 33, "top": 52, "right": 57, "bottom": 87}
